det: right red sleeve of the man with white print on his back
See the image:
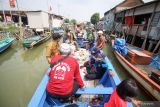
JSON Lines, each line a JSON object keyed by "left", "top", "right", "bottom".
{"left": 74, "top": 62, "right": 84, "bottom": 88}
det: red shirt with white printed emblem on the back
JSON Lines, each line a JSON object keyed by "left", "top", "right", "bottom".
{"left": 47, "top": 55, "right": 84, "bottom": 95}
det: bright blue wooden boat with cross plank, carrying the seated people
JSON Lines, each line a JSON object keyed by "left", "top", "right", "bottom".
{"left": 28, "top": 50, "right": 133, "bottom": 107}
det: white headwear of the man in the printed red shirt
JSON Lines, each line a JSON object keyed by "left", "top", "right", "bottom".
{"left": 60, "top": 43, "right": 71, "bottom": 54}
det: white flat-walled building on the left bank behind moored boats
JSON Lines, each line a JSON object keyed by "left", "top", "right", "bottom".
{"left": 26, "top": 11, "right": 63, "bottom": 29}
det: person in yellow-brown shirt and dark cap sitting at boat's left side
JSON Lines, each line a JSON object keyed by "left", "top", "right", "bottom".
{"left": 46, "top": 33, "right": 61, "bottom": 64}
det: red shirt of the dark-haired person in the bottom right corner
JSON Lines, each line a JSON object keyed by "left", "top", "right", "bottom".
{"left": 104, "top": 89, "right": 127, "bottom": 107}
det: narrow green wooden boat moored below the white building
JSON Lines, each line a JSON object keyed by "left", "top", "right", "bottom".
{"left": 23, "top": 34, "right": 51, "bottom": 48}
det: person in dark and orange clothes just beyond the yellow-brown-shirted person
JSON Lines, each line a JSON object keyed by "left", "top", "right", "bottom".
{"left": 63, "top": 29, "right": 78, "bottom": 50}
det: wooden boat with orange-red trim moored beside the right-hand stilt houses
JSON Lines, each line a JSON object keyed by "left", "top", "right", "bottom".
{"left": 112, "top": 41, "right": 160, "bottom": 101}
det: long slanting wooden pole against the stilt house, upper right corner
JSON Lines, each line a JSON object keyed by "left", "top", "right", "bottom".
{"left": 142, "top": 3, "right": 158, "bottom": 49}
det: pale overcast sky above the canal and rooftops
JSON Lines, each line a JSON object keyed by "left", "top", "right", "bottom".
{"left": 0, "top": 0, "right": 155, "bottom": 21}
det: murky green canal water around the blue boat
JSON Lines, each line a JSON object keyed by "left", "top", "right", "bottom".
{"left": 0, "top": 41, "right": 151, "bottom": 107}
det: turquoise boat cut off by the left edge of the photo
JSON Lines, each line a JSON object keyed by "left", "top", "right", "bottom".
{"left": 0, "top": 37, "right": 15, "bottom": 53}
